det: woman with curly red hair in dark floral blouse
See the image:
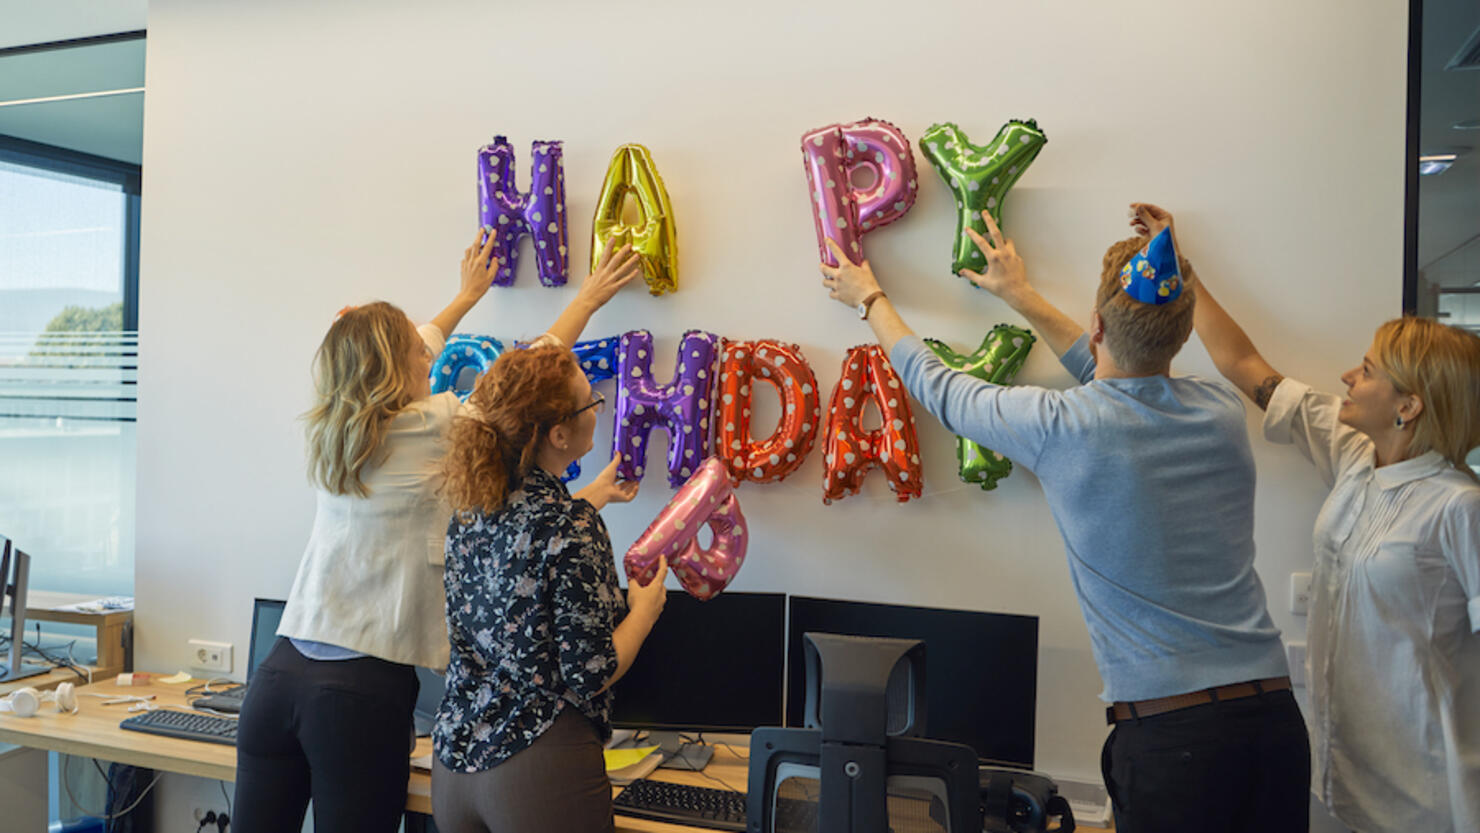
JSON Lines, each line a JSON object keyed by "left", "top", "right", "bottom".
{"left": 432, "top": 338, "right": 667, "bottom": 833}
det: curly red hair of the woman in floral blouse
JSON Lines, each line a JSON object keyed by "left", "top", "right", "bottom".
{"left": 443, "top": 346, "right": 580, "bottom": 513}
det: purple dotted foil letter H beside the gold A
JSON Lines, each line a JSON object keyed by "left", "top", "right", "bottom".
{"left": 478, "top": 136, "right": 567, "bottom": 287}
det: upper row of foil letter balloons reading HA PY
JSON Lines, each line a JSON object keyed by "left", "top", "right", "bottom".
{"left": 478, "top": 118, "right": 1048, "bottom": 287}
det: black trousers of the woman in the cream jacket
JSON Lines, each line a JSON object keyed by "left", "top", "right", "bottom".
{"left": 231, "top": 639, "right": 420, "bottom": 833}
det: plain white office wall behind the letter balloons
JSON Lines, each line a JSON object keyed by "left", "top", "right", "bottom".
{"left": 136, "top": 0, "right": 1406, "bottom": 828}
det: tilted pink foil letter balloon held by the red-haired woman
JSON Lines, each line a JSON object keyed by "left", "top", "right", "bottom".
{"left": 622, "top": 457, "right": 750, "bottom": 602}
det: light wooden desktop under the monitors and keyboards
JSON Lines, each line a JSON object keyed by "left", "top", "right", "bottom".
{"left": 0, "top": 678, "right": 1097, "bottom": 833}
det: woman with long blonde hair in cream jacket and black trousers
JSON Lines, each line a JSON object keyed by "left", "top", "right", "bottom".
{"left": 232, "top": 231, "right": 642, "bottom": 833}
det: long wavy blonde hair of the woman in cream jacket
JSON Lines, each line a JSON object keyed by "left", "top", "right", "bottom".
{"left": 303, "top": 300, "right": 417, "bottom": 497}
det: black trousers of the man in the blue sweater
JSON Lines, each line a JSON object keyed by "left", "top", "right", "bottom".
{"left": 1100, "top": 691, "right": 1310, "bottom": 833}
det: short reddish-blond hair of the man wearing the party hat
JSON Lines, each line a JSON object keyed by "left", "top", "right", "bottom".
{"left": 1095, "top": 237, "right": 1197, "bottom": 373}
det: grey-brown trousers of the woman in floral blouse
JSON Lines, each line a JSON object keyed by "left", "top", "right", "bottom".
{"left": 432, "top": 707, "right": 614, "bottom": 833}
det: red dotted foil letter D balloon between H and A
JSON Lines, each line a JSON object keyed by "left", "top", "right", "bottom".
{"left": 715, "top": 340, "right": 821, "bottom": 482}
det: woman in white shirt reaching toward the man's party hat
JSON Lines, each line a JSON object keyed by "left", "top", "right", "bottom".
{"left": 1132, "top": 198, "right": 1480, "bottom": 833}
